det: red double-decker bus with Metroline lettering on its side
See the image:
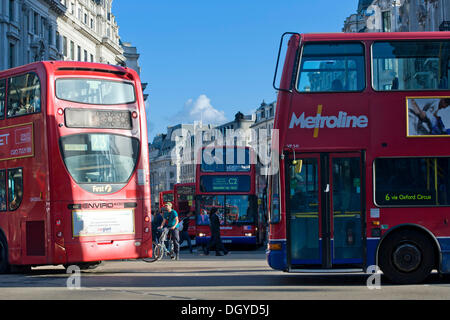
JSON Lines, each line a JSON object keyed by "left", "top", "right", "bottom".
{"left": 267, "top": 32, "right": 450, "bottom": 283}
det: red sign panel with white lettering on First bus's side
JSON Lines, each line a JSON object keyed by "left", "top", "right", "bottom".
{"left": 0, "top": 123, "right": 34, "bottom": 161}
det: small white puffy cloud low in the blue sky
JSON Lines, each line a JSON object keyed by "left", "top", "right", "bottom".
{"left": 174, "top": 94, "right": 227, "bottom": 124}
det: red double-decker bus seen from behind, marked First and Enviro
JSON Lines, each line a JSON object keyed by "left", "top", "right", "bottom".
{"left": 0, "top": 61, "right": 152, "bottom": 272}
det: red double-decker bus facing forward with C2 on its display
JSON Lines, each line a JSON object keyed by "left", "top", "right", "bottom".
{"left": 195, "top": 146, "right": 265, "bottom": 246}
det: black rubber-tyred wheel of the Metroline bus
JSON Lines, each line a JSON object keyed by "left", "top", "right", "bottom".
{"left": 379, "top": 230, "right": 435, "bottom": 284}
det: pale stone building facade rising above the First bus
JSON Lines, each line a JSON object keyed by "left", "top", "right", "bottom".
{"left": 0, "top": 0, "right": 126, "bottom": 70}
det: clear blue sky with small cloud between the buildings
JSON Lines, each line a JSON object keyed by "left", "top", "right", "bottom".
{"left": 112, "top": 0, "right": 358, "bottom": 141}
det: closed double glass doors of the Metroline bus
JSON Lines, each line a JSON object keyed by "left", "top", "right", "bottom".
{"left": 286, "top": 152, "right": 365, "bottom": 269}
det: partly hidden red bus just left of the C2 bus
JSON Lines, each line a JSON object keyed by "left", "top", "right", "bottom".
{"left": 173, "top": 183, "right": 196, "bottom": 238}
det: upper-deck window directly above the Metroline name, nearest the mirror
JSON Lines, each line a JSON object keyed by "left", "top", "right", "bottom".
{"left": 297, "top": 43, "right": 365, "bottom": 92}
